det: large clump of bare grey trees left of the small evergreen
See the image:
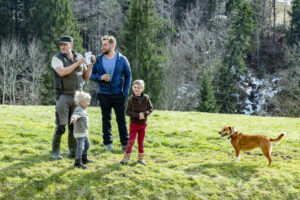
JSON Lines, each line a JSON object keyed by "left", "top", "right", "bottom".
{"left": 164, "top": 1, "right": 227, "bottom": 110}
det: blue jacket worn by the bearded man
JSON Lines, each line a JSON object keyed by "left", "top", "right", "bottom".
{"left": 90, "top": 53, "right": 131, "bottom": 96}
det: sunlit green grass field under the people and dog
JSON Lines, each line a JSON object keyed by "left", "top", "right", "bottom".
{"left": 0, "top": 106, "right": 300, "bottom": 200}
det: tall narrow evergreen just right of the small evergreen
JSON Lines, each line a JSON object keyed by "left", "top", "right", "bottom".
{"left": 216, "top": 0, "right": 253, "bottom": 113}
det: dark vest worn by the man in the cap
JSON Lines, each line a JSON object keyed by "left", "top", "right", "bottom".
{"left": 53, "top": 52, "right": 84, "bottom": 97}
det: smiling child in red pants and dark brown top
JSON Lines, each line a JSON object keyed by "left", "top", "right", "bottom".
{"left": 121, "top": 80, "right": 153, "bottom": 165}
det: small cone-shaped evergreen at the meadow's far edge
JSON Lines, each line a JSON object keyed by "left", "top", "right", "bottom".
{"left": 197, "top": 71, "right": 220, "bottom": 113}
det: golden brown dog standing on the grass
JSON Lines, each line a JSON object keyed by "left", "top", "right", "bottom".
{"left": 219, "top": 126, "right": 286, "bottom": 166}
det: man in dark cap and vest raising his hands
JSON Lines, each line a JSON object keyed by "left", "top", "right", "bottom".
{"left": 51, "top": 36, "right": 96, "bottom": 160}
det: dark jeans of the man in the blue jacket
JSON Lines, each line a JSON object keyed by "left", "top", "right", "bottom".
{"left": 98, "top": 93, "right": 128, "bottom": 145}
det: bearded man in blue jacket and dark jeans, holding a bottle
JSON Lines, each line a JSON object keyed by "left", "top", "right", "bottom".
{"left": 90, "top": 35, "right": 131, "bottom": 151}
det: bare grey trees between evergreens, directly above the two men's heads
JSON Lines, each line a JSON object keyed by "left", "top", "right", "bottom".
{"left": 73, "top": 0, "right": 124, "bottom": 54}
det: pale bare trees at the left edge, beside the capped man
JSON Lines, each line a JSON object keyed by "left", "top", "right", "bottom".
{"left": 0, "top": 38, "right": 45, "bottom": 105}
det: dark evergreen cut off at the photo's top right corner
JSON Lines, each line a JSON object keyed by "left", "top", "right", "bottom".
{"left": 287, "top": 0, "right": 300, "bottom": 45}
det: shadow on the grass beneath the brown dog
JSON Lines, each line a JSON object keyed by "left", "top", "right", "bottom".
{"left": 184, "top": 162, "right": 260, "bottom": 181}
